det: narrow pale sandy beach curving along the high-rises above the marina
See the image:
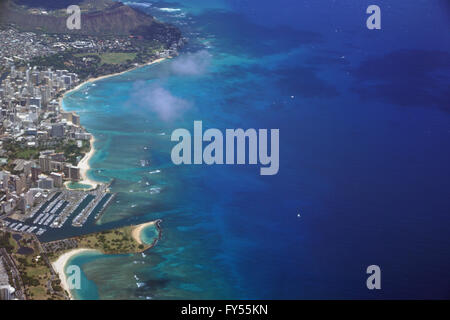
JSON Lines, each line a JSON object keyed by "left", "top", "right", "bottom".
{"left": 58, "top": 57, "right": 170, "bottom": 191}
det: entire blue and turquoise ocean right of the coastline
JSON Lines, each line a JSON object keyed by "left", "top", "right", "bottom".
{"left": 64, "top": 0, "right": 450, "bottom": 299}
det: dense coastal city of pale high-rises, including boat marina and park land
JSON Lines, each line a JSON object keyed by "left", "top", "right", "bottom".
{"left": 0, "top": 0, "right": 185, "bottom": 300}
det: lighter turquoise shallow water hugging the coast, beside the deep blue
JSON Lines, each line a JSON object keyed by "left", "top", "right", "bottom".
{"left": 60, "top": 52, "right": 264, "bottom": 299}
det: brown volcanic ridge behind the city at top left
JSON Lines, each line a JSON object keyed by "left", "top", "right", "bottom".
{"left": 0, "top": 0, "right": 181, "bottom": 42}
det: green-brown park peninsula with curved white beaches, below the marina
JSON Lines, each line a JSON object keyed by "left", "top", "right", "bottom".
{"left": 0, "top": 220, "right": 161, "bottom": 300}
